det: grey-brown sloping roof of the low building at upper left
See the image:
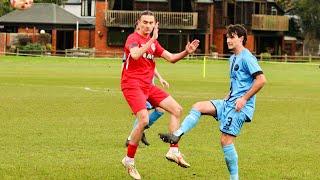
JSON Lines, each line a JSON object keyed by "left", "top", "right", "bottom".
{"left": 0, "top": 3, "right": 92, "bottom": 25}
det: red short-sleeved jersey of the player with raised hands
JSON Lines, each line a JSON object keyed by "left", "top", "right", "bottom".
{"left": 121, "top": 32, "right": 164, "bottom": 88}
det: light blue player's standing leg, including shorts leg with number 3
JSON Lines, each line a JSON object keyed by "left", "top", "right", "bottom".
{"left": 220, "top": 109, "right": 247, "bottom": 180}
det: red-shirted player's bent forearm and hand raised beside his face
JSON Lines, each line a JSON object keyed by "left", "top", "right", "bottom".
{"left": 130, "top": 22, "right": 159, "bottom": 60}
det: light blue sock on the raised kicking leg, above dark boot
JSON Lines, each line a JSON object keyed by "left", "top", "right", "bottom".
{"left": 173, "top": 108, "right": 201, "bottom": 136}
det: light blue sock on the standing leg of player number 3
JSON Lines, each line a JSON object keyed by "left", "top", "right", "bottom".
{"left": 223, "top": 144, "right": 239, "bottom": 180}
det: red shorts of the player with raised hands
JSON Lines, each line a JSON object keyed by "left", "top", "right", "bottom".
{"left": 122, "top": 85, "right": 169, "bottom": 114}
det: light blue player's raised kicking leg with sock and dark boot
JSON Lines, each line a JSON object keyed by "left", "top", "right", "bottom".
{"left": 159, "top": 101, "right": 220, "bottom": 143}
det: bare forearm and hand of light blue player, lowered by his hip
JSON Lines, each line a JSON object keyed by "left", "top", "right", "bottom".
{"left": 236, "top": 74, "right": 267, "bottom": 111}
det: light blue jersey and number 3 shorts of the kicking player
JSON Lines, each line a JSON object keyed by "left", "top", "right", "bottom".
{"left": 211, "top": 49, "right": 262, "bottom": 136}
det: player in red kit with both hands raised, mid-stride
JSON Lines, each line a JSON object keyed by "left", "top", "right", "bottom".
{"left": 121, "top": 11, "right": 199, "bottom": 179}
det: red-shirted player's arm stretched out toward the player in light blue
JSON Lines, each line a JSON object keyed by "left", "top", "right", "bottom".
{"left": 161, "top": 39, "right": 200, "bottom": 63}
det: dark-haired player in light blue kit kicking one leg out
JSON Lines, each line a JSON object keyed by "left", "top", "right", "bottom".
{"left": 159, "top": 25, "right": 266, "bottom": 180}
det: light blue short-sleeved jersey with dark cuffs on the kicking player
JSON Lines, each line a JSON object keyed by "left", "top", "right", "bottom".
{"left": 227, "top": 49, "right": 262, "bottom": 121}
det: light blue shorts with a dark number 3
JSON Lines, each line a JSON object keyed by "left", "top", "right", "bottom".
{"left": 210, "top": 99, "right": 248, "bottom": 136}
